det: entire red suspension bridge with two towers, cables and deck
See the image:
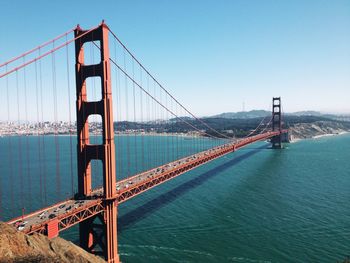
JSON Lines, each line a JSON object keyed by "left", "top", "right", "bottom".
{"left": 0, "top": 22, "right": 287, "bottom": 262}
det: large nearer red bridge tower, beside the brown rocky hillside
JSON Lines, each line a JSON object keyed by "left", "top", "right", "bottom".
{"left": 74, "top": 23, "right": 119, "bottom": 262}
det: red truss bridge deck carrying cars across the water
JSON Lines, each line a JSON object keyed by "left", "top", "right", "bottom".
{"left": 8, "top": 130, "right": 286, "bottom": 234}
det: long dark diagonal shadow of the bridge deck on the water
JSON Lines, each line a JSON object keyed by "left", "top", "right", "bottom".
{"left": 118, "top": 144, "right": 268, "bottom": 232}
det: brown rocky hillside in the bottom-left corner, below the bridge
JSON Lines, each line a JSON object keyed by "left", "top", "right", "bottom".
{"left": 0, "top": 222, "right": 105, "bottom": 263}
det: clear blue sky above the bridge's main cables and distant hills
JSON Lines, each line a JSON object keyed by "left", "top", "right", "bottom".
{"left": 0, "top": 0, "right": 350, "bottom": 116}
